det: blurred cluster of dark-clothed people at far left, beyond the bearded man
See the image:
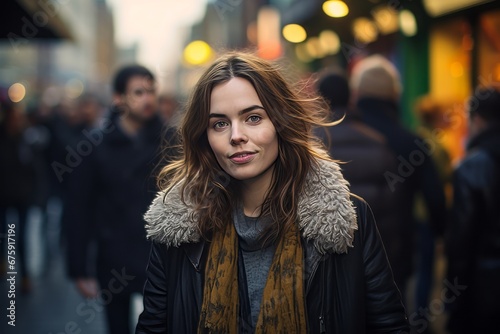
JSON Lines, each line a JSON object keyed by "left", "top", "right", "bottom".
{"left": 0, "top": 90, "right": 103, "bottom": 292}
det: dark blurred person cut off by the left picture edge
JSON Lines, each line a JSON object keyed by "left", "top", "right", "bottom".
{"left": 0, "top": 91, "right": 37, "bottom": 292}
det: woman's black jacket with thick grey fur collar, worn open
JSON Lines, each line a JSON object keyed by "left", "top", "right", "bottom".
{"left": 136, "top": 163, "right": 408, "bottom": 334}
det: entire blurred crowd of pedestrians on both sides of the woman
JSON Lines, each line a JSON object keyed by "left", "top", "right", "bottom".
{"left": 0, "top": 55, "right": 500, "bottom": 333}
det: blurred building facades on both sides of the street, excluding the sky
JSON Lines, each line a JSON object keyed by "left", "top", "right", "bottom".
{"left": 0, "top": 0, "right": 500, "bottom": 160}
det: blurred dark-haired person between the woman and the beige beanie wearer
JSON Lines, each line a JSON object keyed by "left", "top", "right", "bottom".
{"left": 316, "top": 69, "right": 397, "bottom": 234}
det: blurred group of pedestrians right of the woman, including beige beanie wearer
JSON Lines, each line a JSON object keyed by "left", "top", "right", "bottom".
{"left": 317, "top": 55, "right": 500, "bottom": 333}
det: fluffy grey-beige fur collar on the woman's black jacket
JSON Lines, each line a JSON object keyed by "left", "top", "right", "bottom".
{"left": 144, "top": 160, "right": 357, "bottom": 254}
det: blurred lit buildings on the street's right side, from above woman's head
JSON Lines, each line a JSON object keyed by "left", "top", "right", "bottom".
{"left": 178, "top": 0, "right": 500, "bottom": 161}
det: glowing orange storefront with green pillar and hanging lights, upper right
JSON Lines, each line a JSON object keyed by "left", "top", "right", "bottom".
{"left": 282, "top": 0, "right": 500, "bottom": 162}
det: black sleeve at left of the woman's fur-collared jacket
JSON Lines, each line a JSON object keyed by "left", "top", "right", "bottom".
{"left": 135, "top": 242, "right": 168, "bottom": 334}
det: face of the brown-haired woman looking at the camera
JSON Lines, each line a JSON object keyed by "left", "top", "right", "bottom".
{"left": 207, "top": 78, "right": 278, "bottom": 190}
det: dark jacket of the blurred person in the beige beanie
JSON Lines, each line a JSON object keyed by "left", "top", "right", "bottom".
{"left": 357, "top": 97, "right": 447, "bottom": 289}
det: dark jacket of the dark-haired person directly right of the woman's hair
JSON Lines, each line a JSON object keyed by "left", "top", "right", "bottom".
{"left": 321, "top": 111, "right": 411, "bottom": 288}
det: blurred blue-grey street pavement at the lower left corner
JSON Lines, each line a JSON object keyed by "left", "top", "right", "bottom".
{"left": 0, "top": 205, "right": 113, "bottom": 334}
